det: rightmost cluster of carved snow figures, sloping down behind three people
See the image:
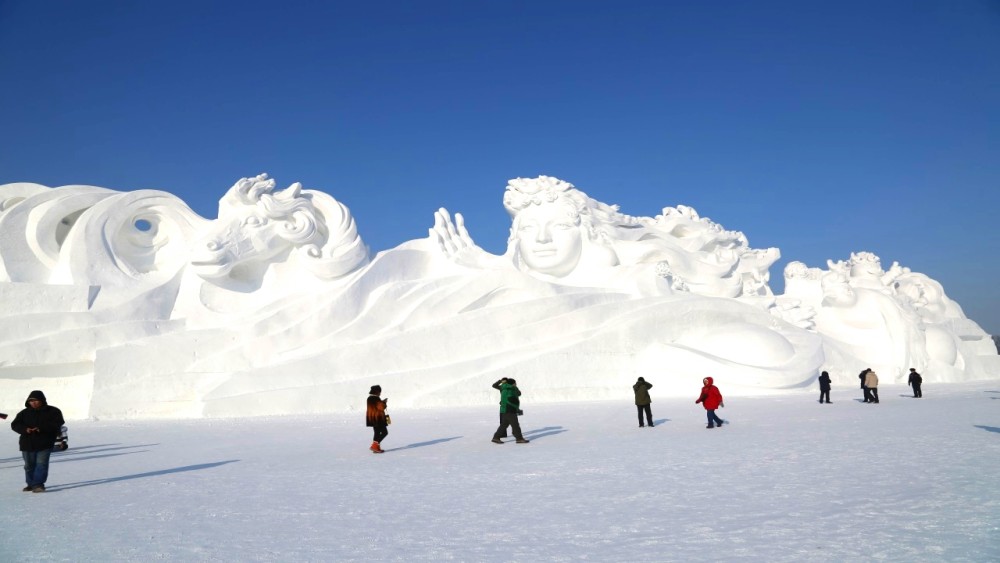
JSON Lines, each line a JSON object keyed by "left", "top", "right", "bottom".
{"left": 779, "top": 252, "right": 1000, "bottom": 384}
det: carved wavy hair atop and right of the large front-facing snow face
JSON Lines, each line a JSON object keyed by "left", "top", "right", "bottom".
{"left": 503, "top": 176, "right": 640, "bottom": 246}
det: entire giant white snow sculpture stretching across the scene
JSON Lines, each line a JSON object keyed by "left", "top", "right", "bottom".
{"left": 0, "top": 175, "right": 1000, "bottom": 418}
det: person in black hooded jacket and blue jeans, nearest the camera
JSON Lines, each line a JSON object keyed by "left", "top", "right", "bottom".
{"left": 10, "top": 391, "right": 66, "bottom": 493}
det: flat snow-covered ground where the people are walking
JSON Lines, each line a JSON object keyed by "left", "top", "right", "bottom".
{"left": 0, "top": 378, "right": 1000, "bottom": 562}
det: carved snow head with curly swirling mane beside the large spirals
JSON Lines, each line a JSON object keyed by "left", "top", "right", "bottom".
{"left": 172, "top": 174, "right": 369, "bottom": 326}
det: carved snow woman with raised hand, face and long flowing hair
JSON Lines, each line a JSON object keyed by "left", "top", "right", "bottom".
{"left": 430, "top": 176, "right": 780, "bottom": 297}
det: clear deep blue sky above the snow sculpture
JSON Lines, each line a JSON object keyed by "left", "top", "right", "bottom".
{"left": 0, "top": 0, "right": 1000, "bottom": 334}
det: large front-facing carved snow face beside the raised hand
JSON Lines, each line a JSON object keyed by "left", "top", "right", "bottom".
{"left": 515, "top": 200, "right": 583, "bottom": 277}
